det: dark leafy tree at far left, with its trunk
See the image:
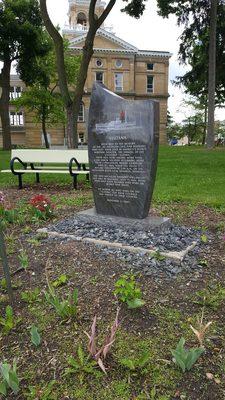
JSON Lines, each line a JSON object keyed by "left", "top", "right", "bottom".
{"left": 0, "top": 0, "right": 47, "bottom": 150}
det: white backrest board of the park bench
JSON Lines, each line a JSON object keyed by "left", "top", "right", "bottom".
{"left": 11, "top": 149, "right": 89, "bottom": 164}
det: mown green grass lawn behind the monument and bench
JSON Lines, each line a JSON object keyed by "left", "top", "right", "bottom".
{"left": 0, "top": 146, "right": 225, "bottom": 208}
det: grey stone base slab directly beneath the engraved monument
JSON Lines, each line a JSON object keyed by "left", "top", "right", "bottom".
{"left": 77, "top": 208, "right": 170, "bottom": 232}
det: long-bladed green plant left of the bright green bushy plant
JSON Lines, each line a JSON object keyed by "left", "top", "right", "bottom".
{"left": 45, "top": 285, "right": 78, "bottom": 320}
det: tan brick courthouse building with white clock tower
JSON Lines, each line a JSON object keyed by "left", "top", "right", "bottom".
{"left": 0, "top": 0, "right": 171, "bottom": 147}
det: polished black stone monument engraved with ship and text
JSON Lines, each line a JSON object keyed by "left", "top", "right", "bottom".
{"left": 88, "top": 83, "right": 159, "bottom": 219}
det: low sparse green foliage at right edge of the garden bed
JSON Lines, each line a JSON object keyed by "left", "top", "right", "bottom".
{"left": 194, "top": 284, "right": 225, "bottom": 311}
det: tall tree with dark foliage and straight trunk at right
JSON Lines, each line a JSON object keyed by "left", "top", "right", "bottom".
{"left": 157, "top": 0, "right": 225, "bottom": 148}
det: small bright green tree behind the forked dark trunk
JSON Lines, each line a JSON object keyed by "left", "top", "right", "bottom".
{"left": 11, "top": 38, "right": 80, "bottom": 148}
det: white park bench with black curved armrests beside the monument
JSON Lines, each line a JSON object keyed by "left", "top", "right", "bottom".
{"left": 1, "top": 149, "right": 89, "bottom": 189}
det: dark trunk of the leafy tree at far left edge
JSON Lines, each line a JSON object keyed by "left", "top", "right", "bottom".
{"left": 0, "top": 58, "right": 12, "bottom": 150}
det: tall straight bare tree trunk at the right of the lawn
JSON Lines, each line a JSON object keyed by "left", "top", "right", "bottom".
{"left": 206, "top": 0, "right": 217, "bottom": 149}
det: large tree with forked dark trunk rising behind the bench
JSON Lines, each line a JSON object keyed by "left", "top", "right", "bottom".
{"left": 40, "top": 0, "right": 145, "bottom": 147}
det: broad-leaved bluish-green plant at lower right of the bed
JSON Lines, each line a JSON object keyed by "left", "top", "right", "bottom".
{"left": 171, "top": 337, "right": 204, "bottom": 372}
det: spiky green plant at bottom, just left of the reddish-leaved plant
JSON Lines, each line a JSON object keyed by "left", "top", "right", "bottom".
{"left": 65, "top": 345, "right": 101, "bottom": 385}
